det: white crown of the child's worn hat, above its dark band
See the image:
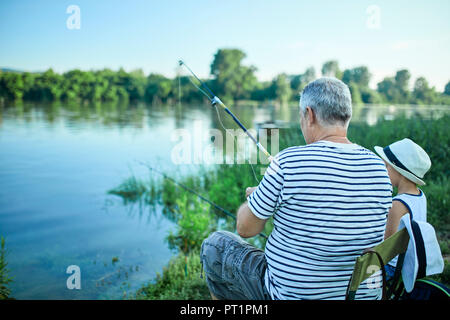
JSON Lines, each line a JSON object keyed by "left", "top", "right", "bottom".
{"left": 389, "top": 138, "right": 431, "bottom": 178}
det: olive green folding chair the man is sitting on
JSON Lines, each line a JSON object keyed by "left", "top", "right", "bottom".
{"left": 346, "top": 228, "right": 409, "bottom": 300}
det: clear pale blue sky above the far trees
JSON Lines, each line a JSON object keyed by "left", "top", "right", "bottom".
{"left": 0, "top": 0, "right": 450, "bottom": 90}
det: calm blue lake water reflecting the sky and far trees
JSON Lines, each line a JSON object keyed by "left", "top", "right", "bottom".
{"left": 0, "top": 104, "right": 448, "bottom": 299}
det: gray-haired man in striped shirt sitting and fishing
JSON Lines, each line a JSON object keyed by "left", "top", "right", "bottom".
{"left": 201, "top": 78, "right": 392, "bottom": 299}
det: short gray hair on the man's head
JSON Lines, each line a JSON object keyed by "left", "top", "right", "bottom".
{"left": 300, "top": 77, "right": 352, "bottom": 126}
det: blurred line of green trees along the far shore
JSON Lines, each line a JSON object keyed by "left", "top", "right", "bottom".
{"left": 0, "top": 49, "right": 450, "bottom": 105}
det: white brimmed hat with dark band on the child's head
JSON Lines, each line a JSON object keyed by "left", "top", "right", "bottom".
{"left": 375, "top": 138, "right": 431, "bottom": 185}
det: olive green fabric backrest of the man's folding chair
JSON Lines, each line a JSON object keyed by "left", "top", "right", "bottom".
{"left": 346, "top": 228, "right": 409, "bottom": 300}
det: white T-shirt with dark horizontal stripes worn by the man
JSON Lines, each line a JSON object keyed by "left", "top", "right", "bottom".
{"left": 247, "top": 141, "right": 392, "bottom": 300}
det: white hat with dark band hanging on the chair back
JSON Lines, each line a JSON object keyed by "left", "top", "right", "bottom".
{"left": 399, "top": 213, "right": 444, "bottom": 292}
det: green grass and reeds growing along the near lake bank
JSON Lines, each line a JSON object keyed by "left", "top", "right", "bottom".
{"left": 110, "top": 115, "right": 450, "bottom": 299}
